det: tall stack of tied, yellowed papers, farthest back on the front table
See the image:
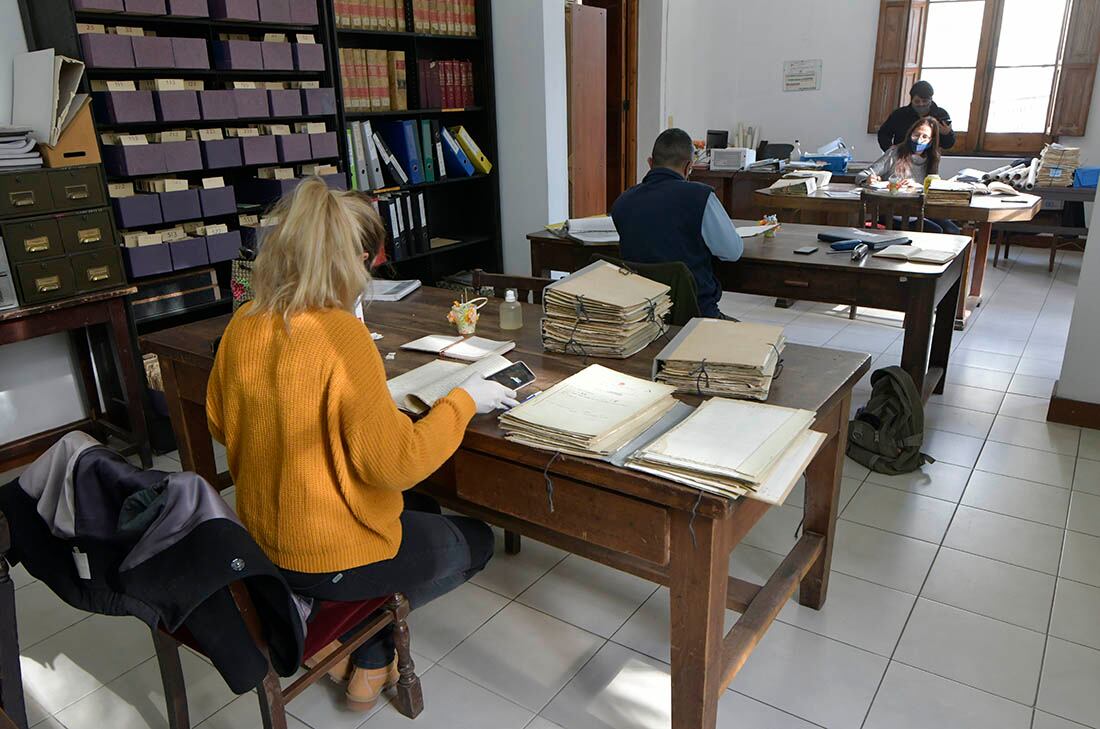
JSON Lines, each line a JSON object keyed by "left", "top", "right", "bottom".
{"left": 542, "top": 261, "right": 672, "bottom": 360}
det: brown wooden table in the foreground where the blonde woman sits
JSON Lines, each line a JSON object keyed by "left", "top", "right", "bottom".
{"left": 142, "top": 288, "right": 870, "bottom": 729}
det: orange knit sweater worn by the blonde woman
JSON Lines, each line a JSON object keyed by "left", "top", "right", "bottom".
{"left": 207, "top": 307, "right": 475, "bottom": 572}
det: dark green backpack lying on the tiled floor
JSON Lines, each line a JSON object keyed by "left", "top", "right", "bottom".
{"left": 848, "top": 367, "right": 935, "bottom": 475}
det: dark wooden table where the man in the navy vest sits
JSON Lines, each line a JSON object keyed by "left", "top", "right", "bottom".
{"left": 527, "top": 225, "right": 970, "bottom": 400}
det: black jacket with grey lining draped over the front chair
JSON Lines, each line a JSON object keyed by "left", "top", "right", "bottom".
{"left": 0, "top": 432, "right": 308, "bottom": 694}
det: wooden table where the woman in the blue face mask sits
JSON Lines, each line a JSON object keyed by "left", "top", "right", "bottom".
{"left": 754, "top": 183, "right": 1043, "bottom": 329}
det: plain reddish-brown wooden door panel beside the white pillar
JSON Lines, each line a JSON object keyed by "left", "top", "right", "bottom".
{"left": 565, "top": 4, "right": 608, "bottom": 218}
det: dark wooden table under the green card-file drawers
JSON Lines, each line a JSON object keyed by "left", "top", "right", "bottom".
{"left": 0, "top": 286, "right": 153, "bottom": 468}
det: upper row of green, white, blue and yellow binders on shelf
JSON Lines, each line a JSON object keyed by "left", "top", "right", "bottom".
{"left": 347, "top": 119, "right": 493, "bottom": 190}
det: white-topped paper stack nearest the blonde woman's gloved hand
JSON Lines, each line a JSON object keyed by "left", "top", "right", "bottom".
{"left": 499, "top": 365, "right": 677, "bottom": 459}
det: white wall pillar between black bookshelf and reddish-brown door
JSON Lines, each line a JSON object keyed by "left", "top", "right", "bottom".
{"left": 493, "top": 0, "right": 569, "bottom": 275}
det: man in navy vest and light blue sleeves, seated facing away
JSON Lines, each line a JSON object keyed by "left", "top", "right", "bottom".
{"left": 612, "top": 129, "right": 745, "bottom": 319}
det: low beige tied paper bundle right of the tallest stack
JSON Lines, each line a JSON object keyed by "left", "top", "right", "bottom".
{"left": 653, "top": 319, "right": 787, "bottom": 400}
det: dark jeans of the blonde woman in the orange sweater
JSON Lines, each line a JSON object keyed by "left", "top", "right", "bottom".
{"left": 283, "top": 493, "right": 493, "bottom": 669}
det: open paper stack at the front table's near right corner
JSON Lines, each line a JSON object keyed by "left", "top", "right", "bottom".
{"left": 625, "top": 398, "right": 825, "bottom": 504}
